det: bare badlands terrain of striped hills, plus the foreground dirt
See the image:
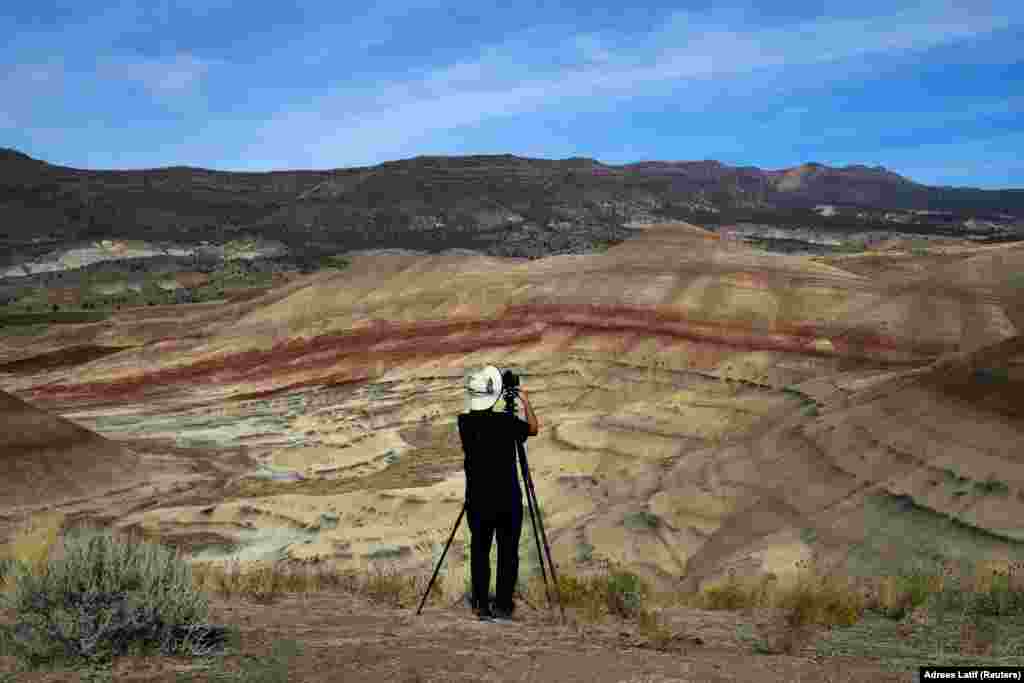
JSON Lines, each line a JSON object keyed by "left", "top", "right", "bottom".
{"left": 0, "top": 211, "right": 1024, "bottom": 683}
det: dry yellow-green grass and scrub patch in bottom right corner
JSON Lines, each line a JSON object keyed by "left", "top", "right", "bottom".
{"left": 673, "top": 562, "right": 1024, "bottom": 665}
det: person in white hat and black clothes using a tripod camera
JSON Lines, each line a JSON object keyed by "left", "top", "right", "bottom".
{"left": 459, "top": 366, "right": 539, "bottom": 620}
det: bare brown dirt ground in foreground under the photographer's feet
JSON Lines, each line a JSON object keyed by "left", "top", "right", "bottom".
{"left": 0, "top": 594, "right": 914, "bottom": 683}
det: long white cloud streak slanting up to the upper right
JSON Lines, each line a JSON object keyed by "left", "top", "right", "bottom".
{"left": 253, "top": 2, "right": 1020, "bottom": 167}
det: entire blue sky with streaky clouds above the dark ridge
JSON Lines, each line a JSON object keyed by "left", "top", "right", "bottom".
{"left": 0, "top": 0, "right": 1024, "bottom": 187}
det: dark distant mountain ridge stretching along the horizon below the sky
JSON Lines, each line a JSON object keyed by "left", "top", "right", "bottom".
{"left": 0, "top": 148, "right": 1024, "bottom": 266}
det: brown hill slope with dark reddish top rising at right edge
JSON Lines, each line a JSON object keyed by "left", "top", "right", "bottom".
{"left": 675, "top": 337, "right": 1024, "bottom": 588}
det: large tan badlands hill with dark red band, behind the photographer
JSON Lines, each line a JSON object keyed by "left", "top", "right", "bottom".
{"left": 0, "top": 223, "right": 1024, "bottom": 610}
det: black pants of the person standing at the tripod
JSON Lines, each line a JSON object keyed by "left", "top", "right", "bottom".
{"left": 467, "top": 503, "right": 522, "bottom": 609}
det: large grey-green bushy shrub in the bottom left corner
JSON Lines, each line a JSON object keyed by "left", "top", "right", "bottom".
{"left": 3, "top": 529, "right": 225, "bottom": 666}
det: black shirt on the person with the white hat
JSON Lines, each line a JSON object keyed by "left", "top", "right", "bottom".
{"left": 459, "top": 410, "right": 529, "bottom": 512}
